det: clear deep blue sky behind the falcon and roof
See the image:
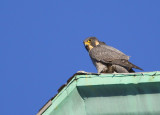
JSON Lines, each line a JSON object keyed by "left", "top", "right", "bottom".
{"left": 0, "top": 0, "right": 160, "bottom": 115}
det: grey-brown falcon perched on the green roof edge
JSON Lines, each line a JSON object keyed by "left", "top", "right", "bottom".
{"left": 83, "top": 37, "right": 143, "bottom": 73}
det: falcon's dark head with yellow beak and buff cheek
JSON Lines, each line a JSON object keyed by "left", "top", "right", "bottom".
{"left": 83, "top": 37, "right": 105, "bottom": 51}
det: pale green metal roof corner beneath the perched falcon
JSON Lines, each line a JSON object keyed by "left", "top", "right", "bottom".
{"left": 37, "top": 72, "right": 160, "bottom": 115}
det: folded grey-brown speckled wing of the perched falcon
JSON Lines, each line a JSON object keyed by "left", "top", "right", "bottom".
{"left": 89, "top": 45, "right": 129, "bottom": 63}
